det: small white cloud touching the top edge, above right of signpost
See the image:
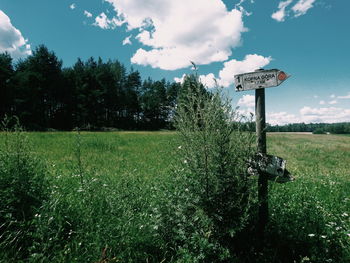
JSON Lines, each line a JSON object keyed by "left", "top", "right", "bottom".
{"left": 271, "top": 0, "right": 316, "bottom": 22}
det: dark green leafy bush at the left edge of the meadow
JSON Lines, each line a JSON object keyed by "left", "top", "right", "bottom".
{"left": 0, "top": 117, "right": 48, "bottom": 259}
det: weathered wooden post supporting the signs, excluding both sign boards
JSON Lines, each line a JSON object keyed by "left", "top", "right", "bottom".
{"left": 255, "top": 89, "right": 268, "bottom": 240}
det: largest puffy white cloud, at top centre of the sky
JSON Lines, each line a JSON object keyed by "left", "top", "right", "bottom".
{"left": 105, "top": 0, "right": 246, "bottom": 70}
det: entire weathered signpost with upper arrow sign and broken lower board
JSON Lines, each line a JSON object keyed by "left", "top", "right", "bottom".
{"left": 235, "top": 69, "right": 292, "bottom": 239}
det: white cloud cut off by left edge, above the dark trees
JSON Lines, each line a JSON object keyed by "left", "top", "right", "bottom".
{"left": 0, "top": 10, "right": 32, "bottom": 59}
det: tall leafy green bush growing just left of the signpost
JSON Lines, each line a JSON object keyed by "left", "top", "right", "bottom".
{"left": 152, "top": 75, "right": 254, "bottom": 262}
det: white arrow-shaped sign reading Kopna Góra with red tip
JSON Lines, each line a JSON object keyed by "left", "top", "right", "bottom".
{"left": 235, "top": 69, "right": 290, "bottom": 91}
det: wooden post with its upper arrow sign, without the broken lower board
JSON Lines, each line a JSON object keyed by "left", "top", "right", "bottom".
{"left": 234, "top": 69, "right": 290, "bottom": 240}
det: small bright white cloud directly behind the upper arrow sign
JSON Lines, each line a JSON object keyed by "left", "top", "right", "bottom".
{"left": 218, "top": 54, "right": 272, "bottom": 87}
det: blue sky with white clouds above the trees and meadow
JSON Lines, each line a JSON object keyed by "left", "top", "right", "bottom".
{"left": 0, "top": 0, "right": 350, "bottom": 125}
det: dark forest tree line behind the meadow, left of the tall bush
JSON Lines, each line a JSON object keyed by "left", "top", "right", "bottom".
{"left": 0, "top": 45, "right": 180, "bottom": 130}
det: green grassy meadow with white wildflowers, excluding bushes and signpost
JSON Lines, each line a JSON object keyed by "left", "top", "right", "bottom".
{"left": 0, "top": 131, "right": 350, "bottom": 263}
